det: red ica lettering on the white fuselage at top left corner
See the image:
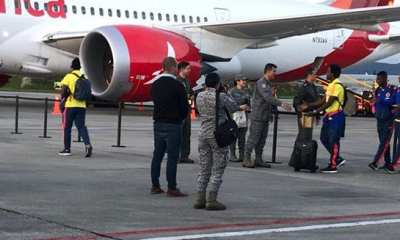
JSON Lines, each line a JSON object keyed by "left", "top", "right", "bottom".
{"left": 0, "top": 0, "right": 67, "bottom": 18}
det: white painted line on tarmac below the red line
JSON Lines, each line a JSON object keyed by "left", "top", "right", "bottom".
{"left": 144, "top": 219, "right": 400, "bottom": 240}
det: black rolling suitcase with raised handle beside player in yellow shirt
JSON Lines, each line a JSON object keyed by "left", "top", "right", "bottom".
{"left": 293, "top": 113, "right": 318, "bottom": 173}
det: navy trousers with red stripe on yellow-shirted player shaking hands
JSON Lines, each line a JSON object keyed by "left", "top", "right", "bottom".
{"left": 320, "top": 113, "right": 346, "bottom": 168}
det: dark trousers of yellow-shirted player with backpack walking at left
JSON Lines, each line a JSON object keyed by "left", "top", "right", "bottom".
{"left": 63, "top": 108, "right": 90, "bottom": 150}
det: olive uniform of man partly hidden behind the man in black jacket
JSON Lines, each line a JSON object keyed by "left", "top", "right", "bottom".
{"left": 176, "top": 76, "right": 194, "bottom": 159}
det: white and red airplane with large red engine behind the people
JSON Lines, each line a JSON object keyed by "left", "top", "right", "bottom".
{"left": 0, "top": 0, "right": 400, "bottom": 101}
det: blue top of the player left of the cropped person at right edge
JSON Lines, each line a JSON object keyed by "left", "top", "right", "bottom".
{"left": 375, "top": 85, "right": 398, "bottom": 120}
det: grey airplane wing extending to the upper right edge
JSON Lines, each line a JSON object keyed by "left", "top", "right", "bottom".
{"left": 183, "top": 6, "right": 400, "bottom": 39}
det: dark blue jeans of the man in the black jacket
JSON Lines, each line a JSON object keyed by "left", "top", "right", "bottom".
{"left": 151, "top": 123, "right": 183, "bottom": 189}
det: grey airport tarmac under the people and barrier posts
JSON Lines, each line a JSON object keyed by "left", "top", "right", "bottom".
{"left": 0, "top": 92, "right": 400, "bottom": 240}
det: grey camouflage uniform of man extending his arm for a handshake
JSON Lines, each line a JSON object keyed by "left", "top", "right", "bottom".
{"left": 246, "top": 77, "right": 283, "bottom": 154}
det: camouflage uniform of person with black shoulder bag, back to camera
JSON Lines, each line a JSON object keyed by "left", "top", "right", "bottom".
{"left": 197, "top": 88, "right": 240, "bottom": 192}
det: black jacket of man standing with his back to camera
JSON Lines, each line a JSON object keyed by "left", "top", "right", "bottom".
{"left": 150, "top": 76, "right": 189, "bottom": 124}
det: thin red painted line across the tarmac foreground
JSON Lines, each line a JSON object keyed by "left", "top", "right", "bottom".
{"left": 32, "top": 212, "right": 400, "bottom": 240}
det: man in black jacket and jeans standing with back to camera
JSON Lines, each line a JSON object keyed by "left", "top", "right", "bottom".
{"left": 150, "top": 57, "right": 189, "bottom": 197}
